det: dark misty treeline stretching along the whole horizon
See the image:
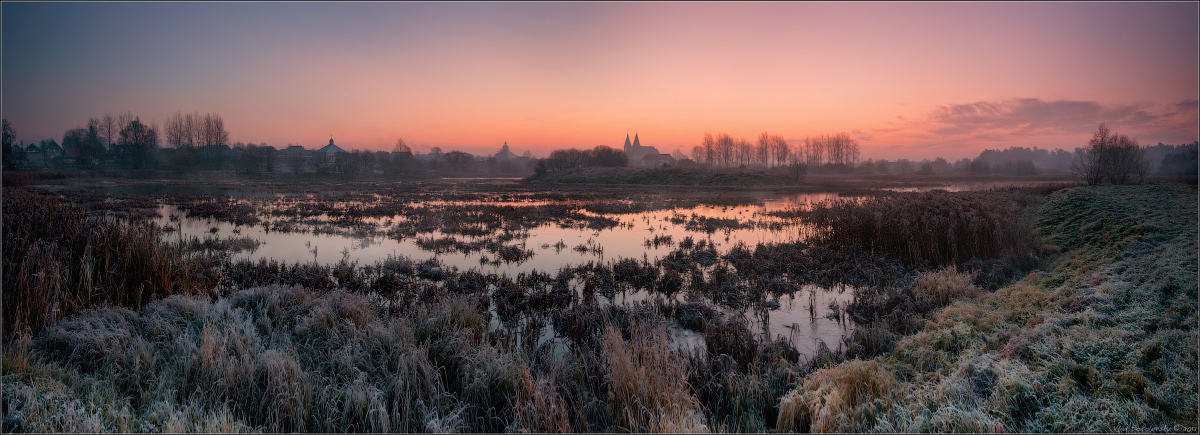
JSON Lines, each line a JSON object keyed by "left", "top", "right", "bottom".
{"left": 4, "top": 112, "right": 1198, "bottom": 181}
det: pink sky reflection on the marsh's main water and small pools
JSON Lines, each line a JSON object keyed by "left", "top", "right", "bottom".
{"left": 160, "top": 183, "right": 1032, "bottom": 358}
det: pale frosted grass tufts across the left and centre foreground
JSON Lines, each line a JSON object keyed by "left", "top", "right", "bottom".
{"left": 2, "top": 282, "right": 707, "bottom": 433}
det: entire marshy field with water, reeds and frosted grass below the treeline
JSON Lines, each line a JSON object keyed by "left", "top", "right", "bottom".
{"left": 2, "top": 174, "right": 1198, "bottom": 433}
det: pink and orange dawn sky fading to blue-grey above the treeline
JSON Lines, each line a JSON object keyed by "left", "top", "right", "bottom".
{"left": 0, "top": 1, "right": 1200, "bottom": 159}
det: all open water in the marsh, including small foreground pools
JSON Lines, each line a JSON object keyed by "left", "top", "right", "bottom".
{"left": 147, "top": 183, "right": 1051, "bottom": 357}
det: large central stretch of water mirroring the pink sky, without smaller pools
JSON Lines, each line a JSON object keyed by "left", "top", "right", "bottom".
{"left": 160, "top": 189, "right": 838, "bottom": 271}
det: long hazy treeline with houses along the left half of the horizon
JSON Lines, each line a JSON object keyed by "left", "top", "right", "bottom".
{"left": 4, "top": 112, "right": 533, "bottom": 178}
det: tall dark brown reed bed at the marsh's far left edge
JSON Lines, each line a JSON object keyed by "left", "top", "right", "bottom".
{"left": 2, "top": 189, "right": 193, "bottom": 340}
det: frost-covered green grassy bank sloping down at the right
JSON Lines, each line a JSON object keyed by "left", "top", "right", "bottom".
{"left": 778, "top": 186, "right": 1198, "bottom": 433}
